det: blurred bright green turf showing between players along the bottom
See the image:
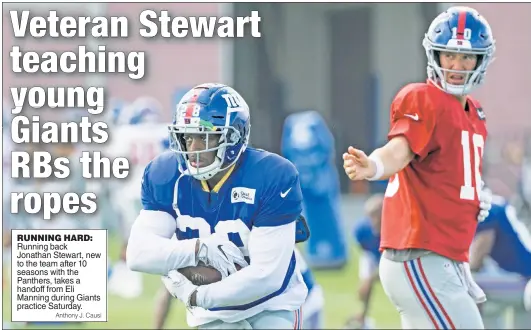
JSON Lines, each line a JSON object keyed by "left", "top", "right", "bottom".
{"left": 3, "top": 239, "right": 400, "bottom": 329}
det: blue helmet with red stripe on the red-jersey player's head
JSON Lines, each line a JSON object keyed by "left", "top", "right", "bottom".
{"left": 422, "top": 7, "right": 495, "bottom": 95}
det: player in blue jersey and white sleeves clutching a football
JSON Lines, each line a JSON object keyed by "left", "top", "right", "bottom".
{"left": 127, "top": 84, "right": 308, "bottom": 329}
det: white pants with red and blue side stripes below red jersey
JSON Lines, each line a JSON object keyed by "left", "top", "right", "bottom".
{"left": 380, "top": 253, "right": 484, "bottom": 329}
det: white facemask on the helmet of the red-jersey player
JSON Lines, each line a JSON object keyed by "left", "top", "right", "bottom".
{"left": 422, "top": 36, "right": 494, "bottom": 96}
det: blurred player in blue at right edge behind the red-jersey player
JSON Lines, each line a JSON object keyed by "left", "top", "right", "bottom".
{"left": 470, "top": 196, "right": 531, "bottom": 329}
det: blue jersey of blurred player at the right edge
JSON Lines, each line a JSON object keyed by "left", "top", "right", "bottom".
{"left": 477, "top": 200, "right": 531, "bottom": 277}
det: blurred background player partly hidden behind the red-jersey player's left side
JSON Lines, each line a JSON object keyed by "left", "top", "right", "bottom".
{"left": 345, "top": 194, "right": 384, "bottom": 329}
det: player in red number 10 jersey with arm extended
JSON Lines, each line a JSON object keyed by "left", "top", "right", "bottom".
{"left": 343, "top": 7, "right": 495, "bottom": 329}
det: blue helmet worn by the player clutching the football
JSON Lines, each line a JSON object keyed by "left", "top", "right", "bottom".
{"left": 168, "top": 84, "right": 251, "bottom": 180}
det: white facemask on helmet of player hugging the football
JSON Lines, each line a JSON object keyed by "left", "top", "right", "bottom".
{"left": 168, "top": 118, "right": 244, "bottom": 180}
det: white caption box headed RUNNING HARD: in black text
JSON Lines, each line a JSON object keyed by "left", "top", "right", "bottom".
{"left": 11, "top": 230, "right": 107, "bottom": 322}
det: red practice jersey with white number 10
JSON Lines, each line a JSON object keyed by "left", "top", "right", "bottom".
{"left": 380, "top": 83, "right": 487, "bottom": 262}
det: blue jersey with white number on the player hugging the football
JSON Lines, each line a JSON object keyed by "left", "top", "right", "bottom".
{"left": 142, "top": 148, "right": 302, "bottom": 310}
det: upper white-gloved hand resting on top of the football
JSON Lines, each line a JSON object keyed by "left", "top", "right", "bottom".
{"left": 196, "top": 233, "right": 249, "bottom": 278}
